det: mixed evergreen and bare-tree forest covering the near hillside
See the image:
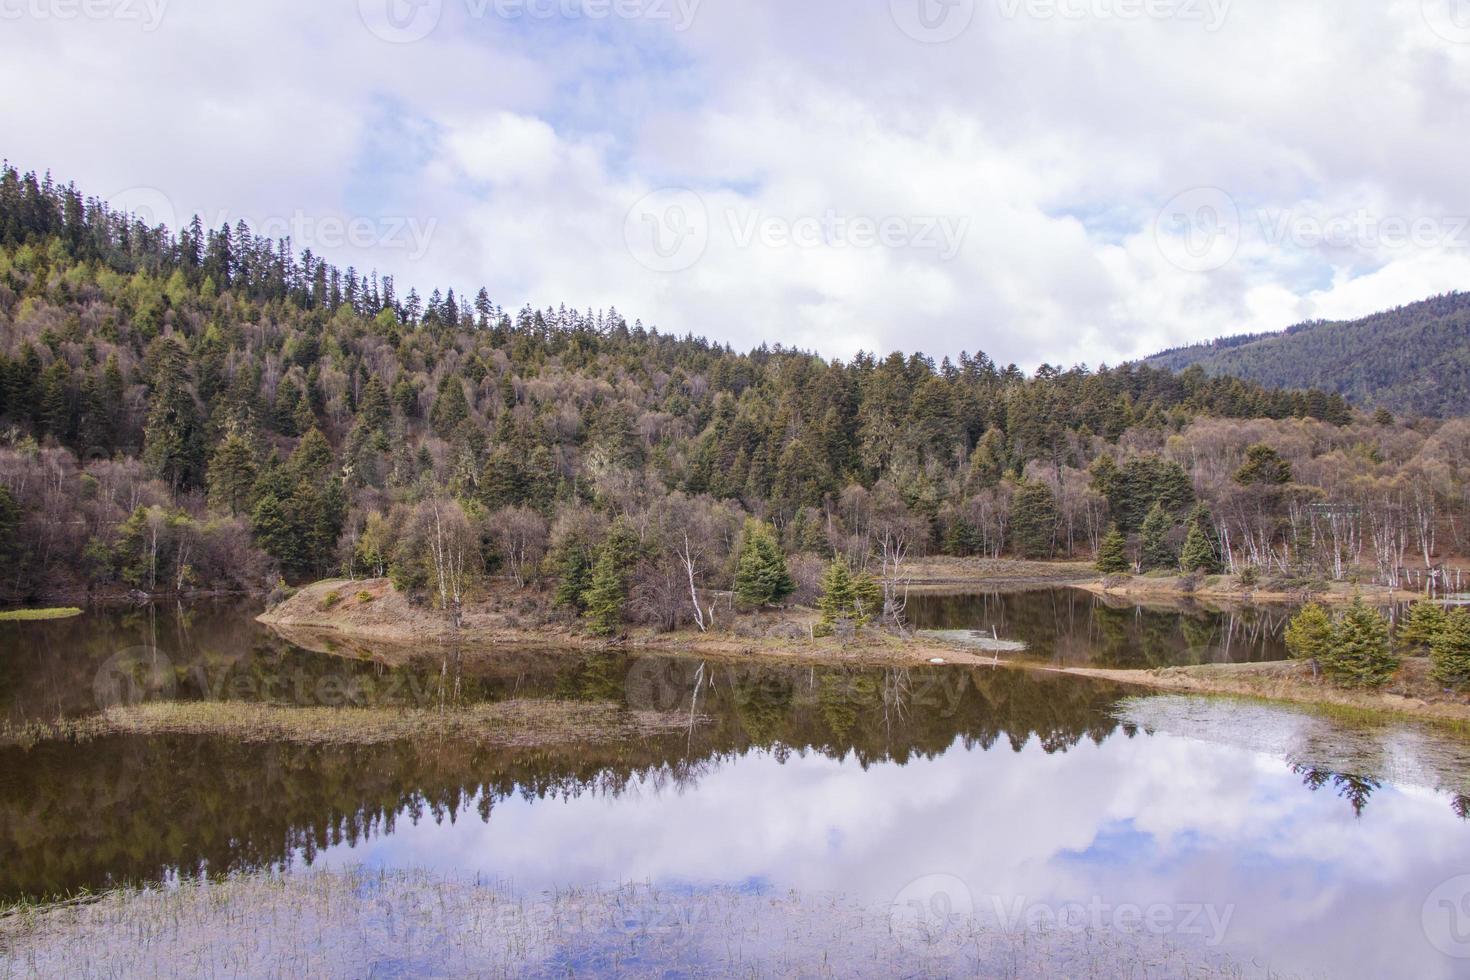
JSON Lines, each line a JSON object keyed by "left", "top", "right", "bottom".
{"left": 0, "top": 165, "right": 1470, "bottom": 627}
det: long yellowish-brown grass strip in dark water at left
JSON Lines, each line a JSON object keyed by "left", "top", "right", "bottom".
{"left": 0, "top": 699, "right": 704, "bottom": 746}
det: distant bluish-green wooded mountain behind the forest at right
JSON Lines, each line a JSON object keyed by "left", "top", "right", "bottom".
{"left": 1145, "top": 292, "right": 1470, "bottom": 417}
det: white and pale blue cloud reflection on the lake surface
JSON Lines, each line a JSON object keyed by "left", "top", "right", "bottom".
{"left": 316, "top": 735, "right": 1470, "bottom": 977}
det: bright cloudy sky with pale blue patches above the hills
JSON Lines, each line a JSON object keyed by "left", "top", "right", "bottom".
{"left": 0, "top": 0, "right": 1470, "bottom": 370}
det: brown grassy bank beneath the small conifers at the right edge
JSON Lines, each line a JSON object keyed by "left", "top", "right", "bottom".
{"left": 1038, "top": 657, "right": 1470, "bottom": 729}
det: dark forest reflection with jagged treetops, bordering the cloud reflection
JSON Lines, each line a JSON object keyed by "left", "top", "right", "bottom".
{"left": 0, "top": 631, "right": 1119, "bottom": 895}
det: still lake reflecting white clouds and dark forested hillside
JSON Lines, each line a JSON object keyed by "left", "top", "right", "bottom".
{"left": 0, "top": 602, "right": 1470, "bottom": 977}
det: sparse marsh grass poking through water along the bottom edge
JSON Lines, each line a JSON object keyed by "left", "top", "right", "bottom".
{"left": 0, "top": 868, "right": 1260, "bottom": 980}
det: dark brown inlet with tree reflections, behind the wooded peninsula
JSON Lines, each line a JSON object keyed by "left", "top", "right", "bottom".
{"left": 910, "top": 589, "right": 1289, "bottom": 667}
